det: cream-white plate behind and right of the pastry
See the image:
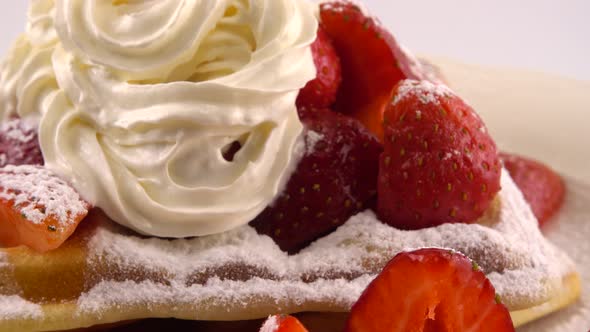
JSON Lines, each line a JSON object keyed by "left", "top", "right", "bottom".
{"left": 431, "top": 59, "right": 590, "bottom": 332}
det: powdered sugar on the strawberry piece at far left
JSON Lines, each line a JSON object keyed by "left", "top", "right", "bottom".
{"left": 0, "top": 165, "right": 87, "bottom": 227}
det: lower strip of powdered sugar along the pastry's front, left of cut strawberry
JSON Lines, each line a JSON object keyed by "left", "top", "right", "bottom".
{"left": 77, "top": 276, "right": 371, "bottom": 319}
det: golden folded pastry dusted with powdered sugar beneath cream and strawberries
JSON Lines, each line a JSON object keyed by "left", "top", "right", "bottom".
{"left": 0, "top": 171, "right": 580, "bottom": 331}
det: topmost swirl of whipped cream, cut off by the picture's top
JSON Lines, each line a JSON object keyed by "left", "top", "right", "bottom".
{"left": 56, "top": 0, "right": 315, "bottom": 83}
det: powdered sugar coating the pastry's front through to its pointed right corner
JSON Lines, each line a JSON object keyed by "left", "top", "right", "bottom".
{"left": 67, "top": 172, "right": 573, "bottom": 318}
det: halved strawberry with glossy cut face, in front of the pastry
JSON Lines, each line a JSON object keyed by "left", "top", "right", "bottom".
{"left": 345, "top": 249, "right": 514, "bottom": 332}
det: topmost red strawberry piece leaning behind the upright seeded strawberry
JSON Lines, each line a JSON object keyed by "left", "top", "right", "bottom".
{"left": 320, "top": 1, "right": 440, "bottom": 140}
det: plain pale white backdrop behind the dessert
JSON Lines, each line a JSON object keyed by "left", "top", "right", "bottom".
{"left": 0, "top": 0, "right": 590, "bottom": 80}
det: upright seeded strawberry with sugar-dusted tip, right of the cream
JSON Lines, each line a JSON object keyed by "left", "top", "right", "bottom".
{"left": 377, "top": 80, "right": 501, "bottom": 229}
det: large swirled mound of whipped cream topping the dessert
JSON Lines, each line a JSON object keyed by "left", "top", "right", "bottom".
{"left": 0, "top": 0, "right": 318, "bottom": 237}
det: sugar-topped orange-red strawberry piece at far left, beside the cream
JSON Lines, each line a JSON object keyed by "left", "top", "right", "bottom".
{"left": 0, "top": 165, "right": 89, "bottom": 252}
